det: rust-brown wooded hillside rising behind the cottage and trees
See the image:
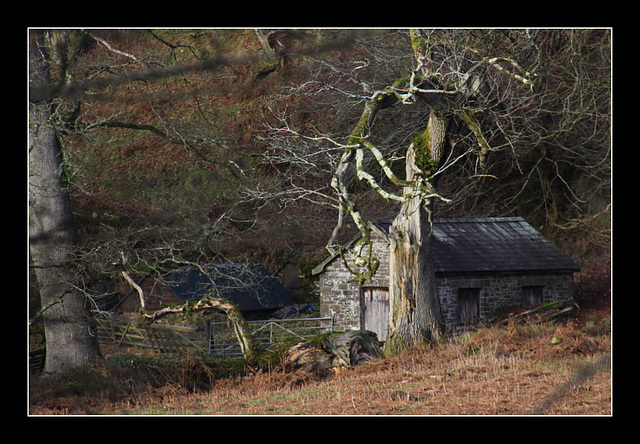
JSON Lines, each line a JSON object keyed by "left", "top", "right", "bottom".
{"left": 47, "top": 29, "right": 610, "bottom": 271}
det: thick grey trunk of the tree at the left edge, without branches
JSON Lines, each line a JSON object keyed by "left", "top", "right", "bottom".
{"left": 29, "top": 32, "right": 98, "bottom": 374}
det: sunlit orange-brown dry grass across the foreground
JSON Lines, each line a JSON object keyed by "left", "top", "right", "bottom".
{"left": 31, "top": 306, "right": 612, "bottom": 415}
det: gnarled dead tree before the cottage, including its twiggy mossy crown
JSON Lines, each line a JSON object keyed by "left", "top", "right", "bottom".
{"left": 304, "top": 29, "right": 534, "bottom": 354}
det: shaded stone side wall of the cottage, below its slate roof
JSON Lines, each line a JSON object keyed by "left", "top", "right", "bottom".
{"left": 436, "top": 273, "right": 573, "bottom": 327}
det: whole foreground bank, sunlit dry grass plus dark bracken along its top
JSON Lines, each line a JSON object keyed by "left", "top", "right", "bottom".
{"left": 28, "top": 248, "right": 613, "bottom": 415}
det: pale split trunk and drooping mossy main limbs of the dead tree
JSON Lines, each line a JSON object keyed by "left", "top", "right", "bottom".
{"left": 330, "top": 30, "right": 451, "bottom": 355}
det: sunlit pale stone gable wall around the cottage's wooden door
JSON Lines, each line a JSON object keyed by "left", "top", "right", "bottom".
{"left": 318, "top": 233, "right": 389, "bottom": 331}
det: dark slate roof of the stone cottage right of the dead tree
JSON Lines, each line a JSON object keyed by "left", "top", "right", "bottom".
{"left": 314, "top": 217, "right": 580, "bottom": 273}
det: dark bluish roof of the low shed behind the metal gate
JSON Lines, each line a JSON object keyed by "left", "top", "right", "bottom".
{"left": 162, "top": 263, "right": 294, "bottom": 311}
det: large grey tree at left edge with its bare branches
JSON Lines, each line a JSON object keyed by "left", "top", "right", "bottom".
{"left": 29, "top": 29, "right": 258, "bottom": 374}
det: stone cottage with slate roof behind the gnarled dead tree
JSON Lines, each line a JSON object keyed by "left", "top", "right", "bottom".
{"left": 313, "top": 217, "right": 580, "bottom": 341}
